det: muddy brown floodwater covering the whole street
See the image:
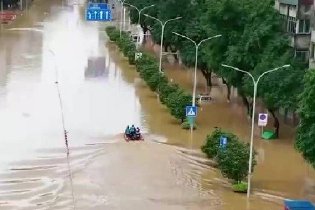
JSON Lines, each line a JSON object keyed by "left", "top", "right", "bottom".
{"left": 0, "top": 0, "right": 315, "bottom": 210}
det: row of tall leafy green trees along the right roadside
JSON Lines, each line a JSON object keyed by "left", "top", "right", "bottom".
{"left": 126, "top": 0, "right": 315, "bottom": 171}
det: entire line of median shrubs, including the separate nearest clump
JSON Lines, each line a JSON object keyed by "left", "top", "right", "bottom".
{"left": 106, "top": 27, "right": 256, "bottom": 192}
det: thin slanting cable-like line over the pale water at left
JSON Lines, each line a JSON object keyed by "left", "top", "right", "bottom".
{"left": 49, "top": 49, "right": 76, "bottom": 210}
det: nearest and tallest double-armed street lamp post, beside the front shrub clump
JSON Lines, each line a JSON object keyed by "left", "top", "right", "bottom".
{"left": 222, "top": 64, "right": 290, "bottom": 198}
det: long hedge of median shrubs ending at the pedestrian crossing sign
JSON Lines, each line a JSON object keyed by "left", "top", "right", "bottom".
{"left": 106, "top": 26, "right": 196, "bottom": 124}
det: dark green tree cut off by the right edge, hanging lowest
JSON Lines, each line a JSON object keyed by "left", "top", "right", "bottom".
{"left": 295, "top": 69, "right": 315, "bottom": 168}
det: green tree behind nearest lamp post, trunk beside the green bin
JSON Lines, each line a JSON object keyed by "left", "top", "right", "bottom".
{"left": 243, "top": 35, "right": 304, "bottom": 137}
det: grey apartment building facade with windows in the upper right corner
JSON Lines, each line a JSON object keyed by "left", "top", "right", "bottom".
{"left": 275, "top": 0, "right": 315, "bottom": 65}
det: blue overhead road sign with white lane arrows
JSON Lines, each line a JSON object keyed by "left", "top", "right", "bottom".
{"left": 86, "top": 3, "right": 112, "bottom": 21}
